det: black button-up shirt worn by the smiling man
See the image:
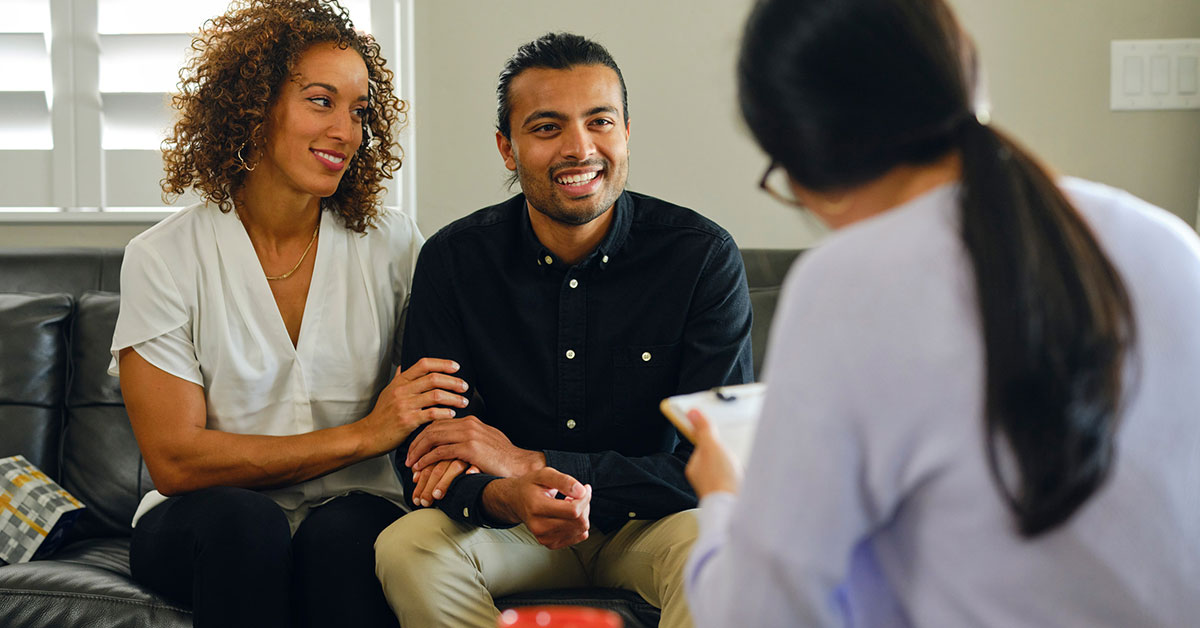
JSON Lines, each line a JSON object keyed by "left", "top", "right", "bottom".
{"left": 397, "top": 192, "right": 752, "bottom": 532}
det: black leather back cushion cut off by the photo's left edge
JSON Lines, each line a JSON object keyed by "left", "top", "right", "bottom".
{"left": 0, "top": 294, "right": 73, "bottom": 479}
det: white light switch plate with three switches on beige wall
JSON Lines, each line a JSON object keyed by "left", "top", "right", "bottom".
{"left": 1110, "top": 40, "right": 1200, "bottom": 110}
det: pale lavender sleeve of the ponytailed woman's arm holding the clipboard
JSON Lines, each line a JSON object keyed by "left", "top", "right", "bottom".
{"left": 684, "top": 255, "right": 894, "bottom": 628}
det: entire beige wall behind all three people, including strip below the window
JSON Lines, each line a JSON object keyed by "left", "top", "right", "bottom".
{"left": 0, "top": 0, "right": 1200, "bottom": 247}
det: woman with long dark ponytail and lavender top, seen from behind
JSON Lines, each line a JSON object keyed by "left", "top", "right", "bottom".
{"left": 685, "top": 0, "right": 1200, "bottom": 627}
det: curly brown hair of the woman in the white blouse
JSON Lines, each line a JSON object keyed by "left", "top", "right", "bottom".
{"left": 161, "top": 0, "right": 408, "bottom": 233}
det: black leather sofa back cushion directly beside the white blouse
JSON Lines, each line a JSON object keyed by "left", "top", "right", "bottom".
{"left": 62, "top": 292, "right": 154, "bottom": 540}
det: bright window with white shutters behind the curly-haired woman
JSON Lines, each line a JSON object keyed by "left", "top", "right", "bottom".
{"left": 0, "top": 0, "right": 412, "bottom": 220}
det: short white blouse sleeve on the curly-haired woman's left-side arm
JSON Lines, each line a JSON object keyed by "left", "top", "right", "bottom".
{"left": 108, "top": 240, "right": 203, "bottom": 385}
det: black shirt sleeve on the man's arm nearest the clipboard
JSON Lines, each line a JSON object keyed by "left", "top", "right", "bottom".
{"left": 545, "top": 235, "right": 754, "bottom": 522}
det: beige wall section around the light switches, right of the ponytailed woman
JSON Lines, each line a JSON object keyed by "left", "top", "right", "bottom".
{"left": 950, "top": 0, "right": 1200, "bottom": 223}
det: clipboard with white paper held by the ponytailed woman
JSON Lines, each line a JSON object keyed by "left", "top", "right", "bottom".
{"left": 659, "top": 383, "right": 767, "bottom": 466}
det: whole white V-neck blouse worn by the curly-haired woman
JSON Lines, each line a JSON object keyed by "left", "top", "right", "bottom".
{"left": 108, "top": 204, "right": 424, "bottom": 531}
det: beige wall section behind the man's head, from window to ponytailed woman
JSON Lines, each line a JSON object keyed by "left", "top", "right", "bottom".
{"left": 413, "top": 0, "right": 812, "bottom": 247}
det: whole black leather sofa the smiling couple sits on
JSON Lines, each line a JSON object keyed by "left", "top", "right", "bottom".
{"left": 0, "top": 249, "right": 798, "bottom": 628}
